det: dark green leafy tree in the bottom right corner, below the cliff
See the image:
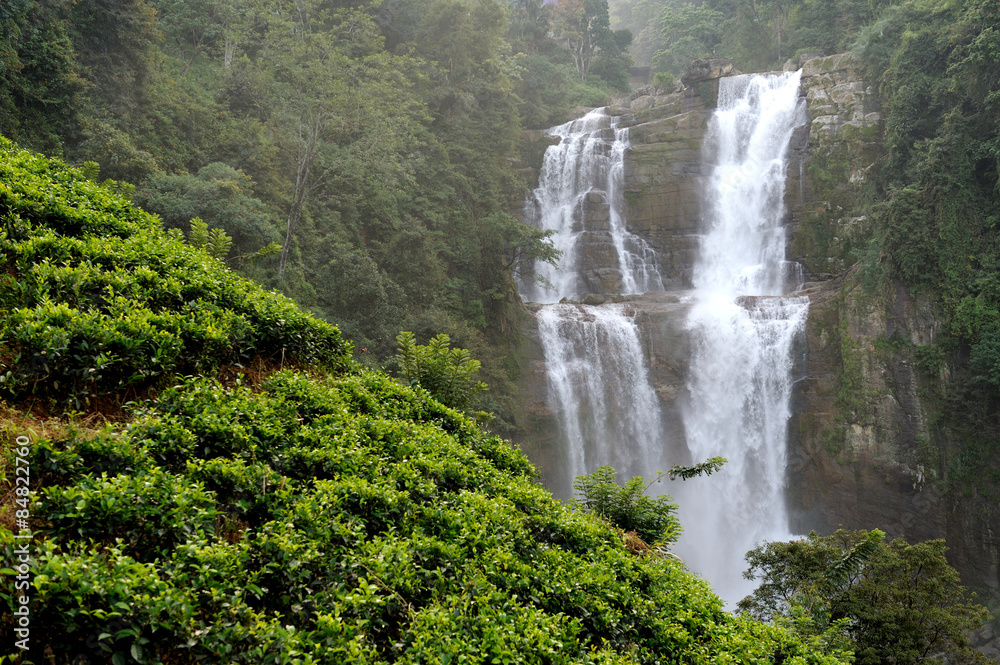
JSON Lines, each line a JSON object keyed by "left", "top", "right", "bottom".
{"left": 739, "top": 531, "right": 989, "bottom": 665}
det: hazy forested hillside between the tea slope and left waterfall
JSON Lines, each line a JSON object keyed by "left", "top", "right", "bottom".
{"left": 0, "top": 0, "right": 629, "bottom": 425}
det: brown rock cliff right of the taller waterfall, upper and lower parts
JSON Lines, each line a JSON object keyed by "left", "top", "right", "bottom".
{"left": 786, "top": 55, "right": 1000, "bottom": 608}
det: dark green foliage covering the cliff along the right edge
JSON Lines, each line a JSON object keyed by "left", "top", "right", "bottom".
{"left": 844, "top": 0, "right": 1000, "bottom": 492}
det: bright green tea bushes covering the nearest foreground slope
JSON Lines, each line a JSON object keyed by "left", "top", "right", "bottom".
{"left": 0, "top": 371, "right": 838, "bottom": 664}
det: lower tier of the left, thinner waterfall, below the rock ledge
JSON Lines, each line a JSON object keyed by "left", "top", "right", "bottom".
{"left": 537, "top": 305, "right": 662, "bottom": 493}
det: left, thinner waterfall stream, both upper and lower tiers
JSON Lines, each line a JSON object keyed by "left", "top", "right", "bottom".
{"left": 520, "top": 109, "right": 663, "bottom": 496}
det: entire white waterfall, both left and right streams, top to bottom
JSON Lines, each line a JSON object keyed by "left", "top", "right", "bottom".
{"left": 520, "top": 73, "right": 808, "bottom": 602}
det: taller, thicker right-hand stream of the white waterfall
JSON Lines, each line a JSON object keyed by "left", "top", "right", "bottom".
{"left": 672, "top": 72, "right": 809, "bottom": 602}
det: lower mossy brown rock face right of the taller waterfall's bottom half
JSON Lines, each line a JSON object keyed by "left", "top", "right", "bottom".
{"left": 789, "top": 275, "right": 946, "bottom": 540}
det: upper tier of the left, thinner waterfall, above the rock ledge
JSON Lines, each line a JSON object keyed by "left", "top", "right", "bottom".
{"left": 520, "top": 109, "right": 663, "bottom": 303}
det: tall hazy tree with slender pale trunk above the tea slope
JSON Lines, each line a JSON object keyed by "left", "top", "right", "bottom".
{"left": 264, "top": 0, "right": 413, "bottom": 279}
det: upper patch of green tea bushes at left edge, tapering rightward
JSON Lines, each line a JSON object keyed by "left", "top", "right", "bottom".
{"left": 0, "top": 139, "right": 350, "bottom": 404}
